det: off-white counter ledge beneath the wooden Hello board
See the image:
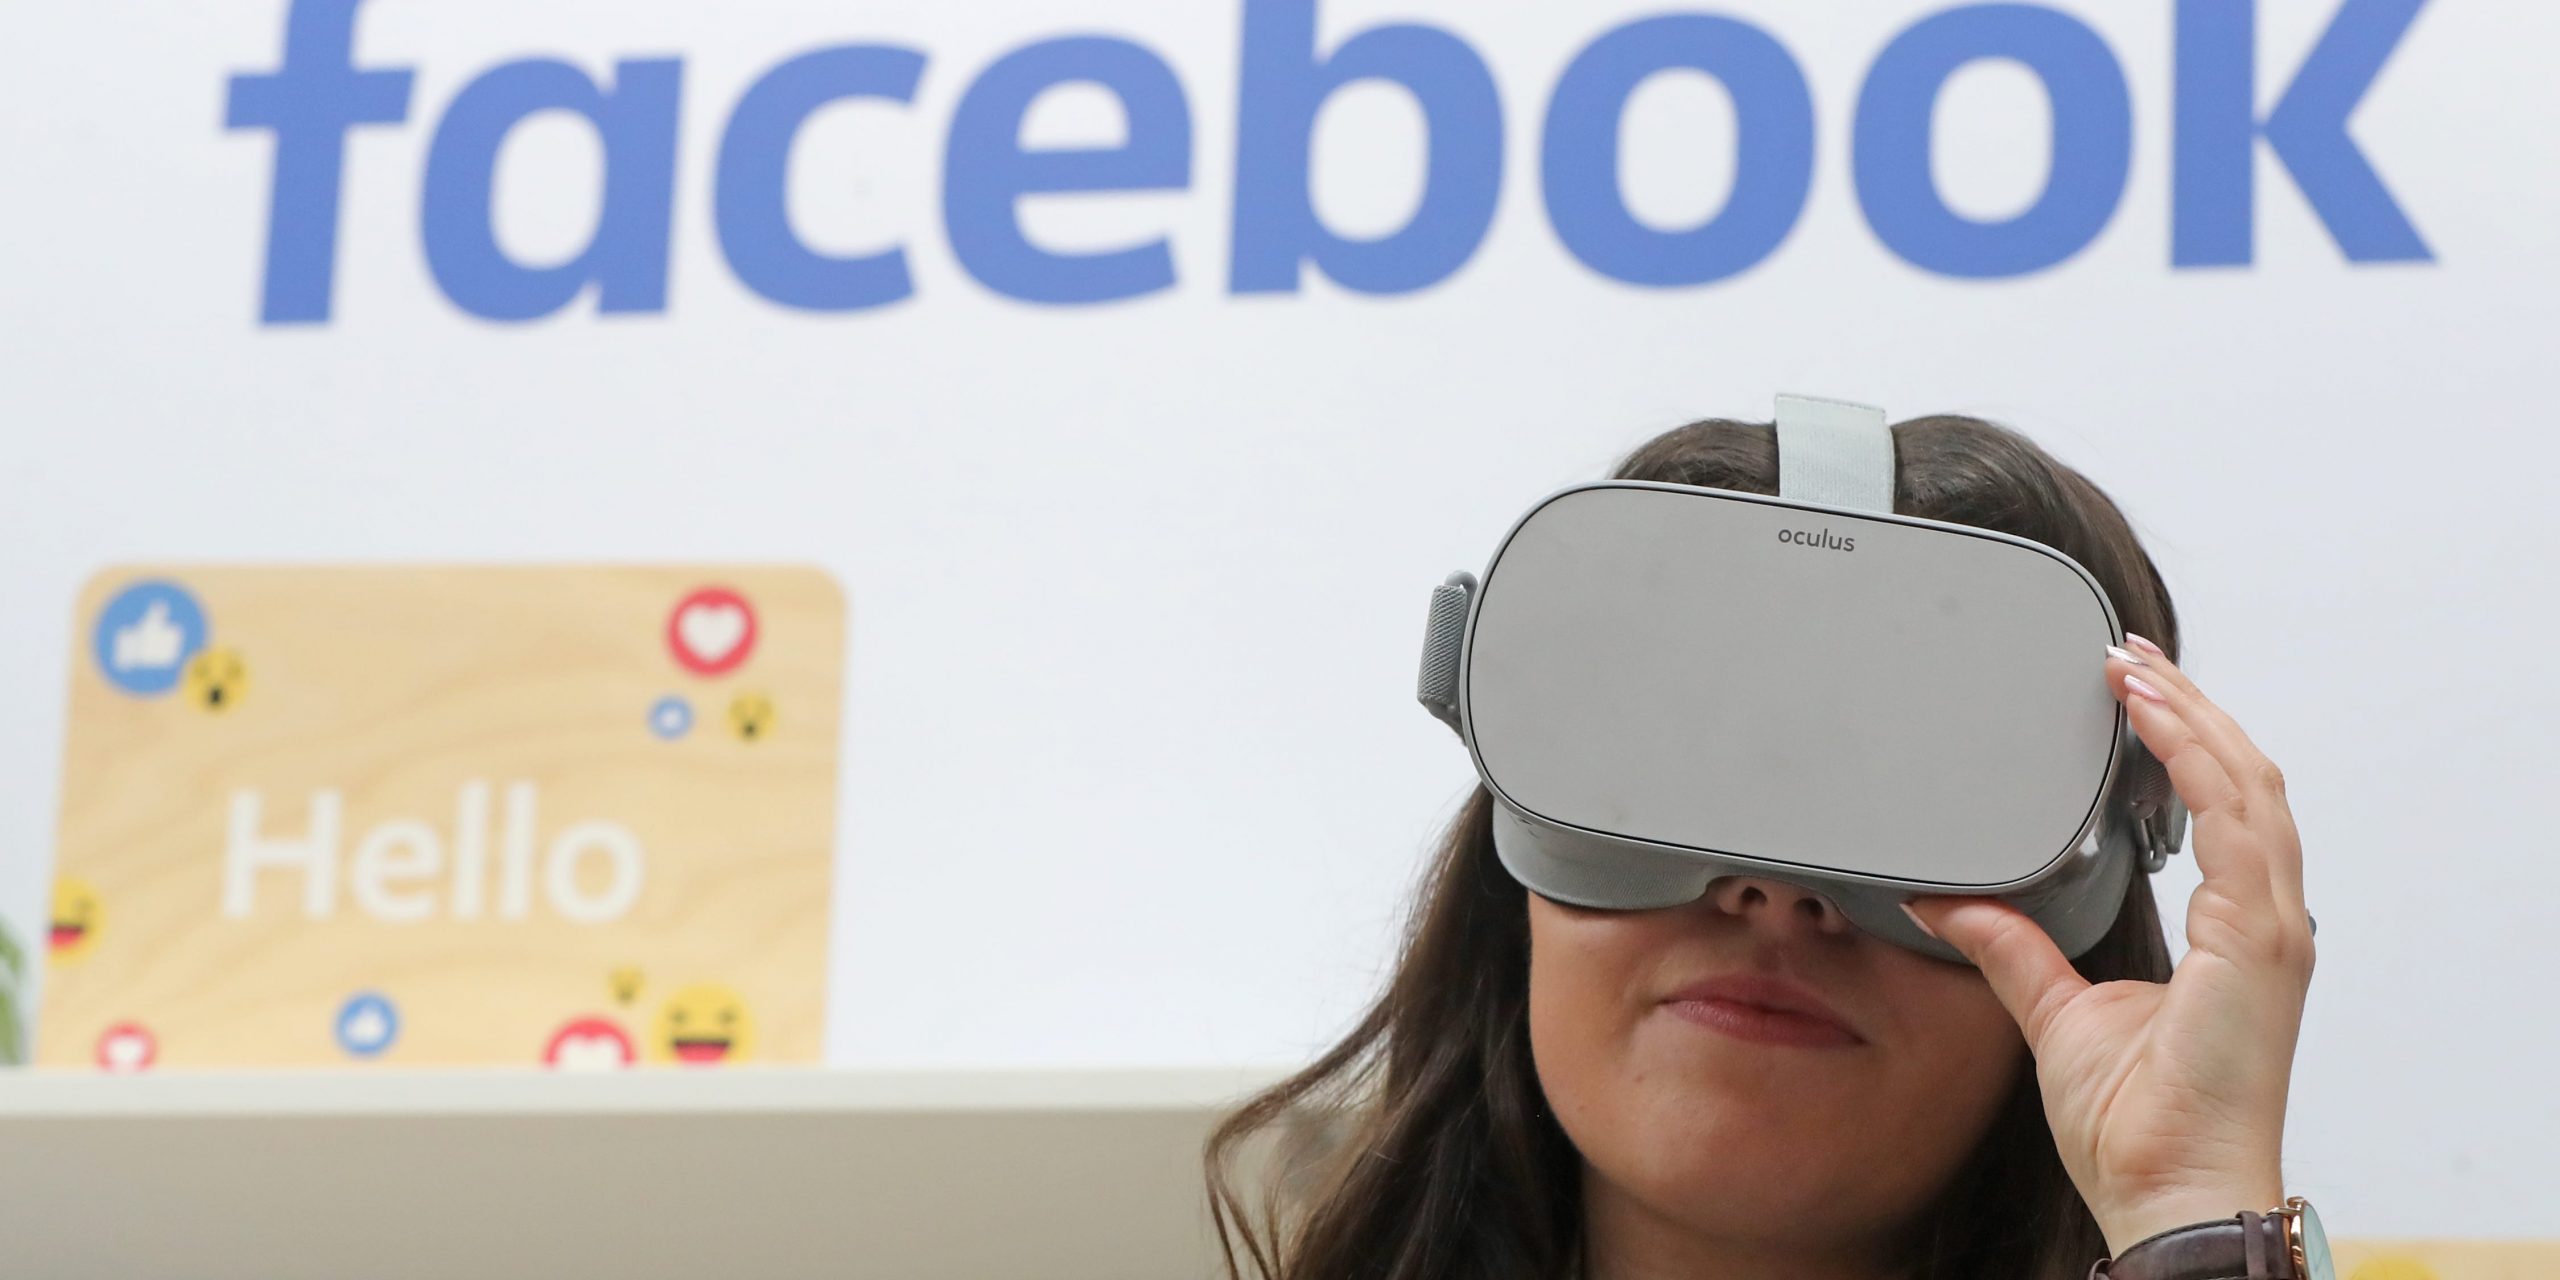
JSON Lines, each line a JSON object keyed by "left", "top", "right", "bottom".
{"left": 0, "top": 1068, "right": 1283, "bottom": 1280}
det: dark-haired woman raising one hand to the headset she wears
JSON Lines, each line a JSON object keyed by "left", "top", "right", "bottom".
{"left": 1208, "top": 417, "right": 2312, "bottom": 1280}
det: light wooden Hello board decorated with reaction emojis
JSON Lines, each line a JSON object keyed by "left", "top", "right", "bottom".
{"left": 36, "top": 566, "right": 845, "bottom": 1070}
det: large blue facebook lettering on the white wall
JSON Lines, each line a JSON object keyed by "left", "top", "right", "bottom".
{"left": 225, "top": 0, "right": 2432, "bottom": 325}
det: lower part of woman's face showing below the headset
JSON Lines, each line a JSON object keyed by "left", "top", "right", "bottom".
{"left": 1528, "top": 876, "right": 2025, "bottom": 1264}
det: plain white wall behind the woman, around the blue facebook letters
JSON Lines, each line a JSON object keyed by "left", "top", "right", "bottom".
{"left": 0, "top": 0, "right": 2560, "bottom": 1236}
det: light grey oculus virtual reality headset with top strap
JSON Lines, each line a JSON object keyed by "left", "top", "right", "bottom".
{"left": 1418, "top": 397, "right": 2186, "bottom": 960}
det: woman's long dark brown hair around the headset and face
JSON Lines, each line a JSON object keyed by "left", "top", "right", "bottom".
{"left": 1203, "top": 415, "right": 2179, "bottom": 1280}
